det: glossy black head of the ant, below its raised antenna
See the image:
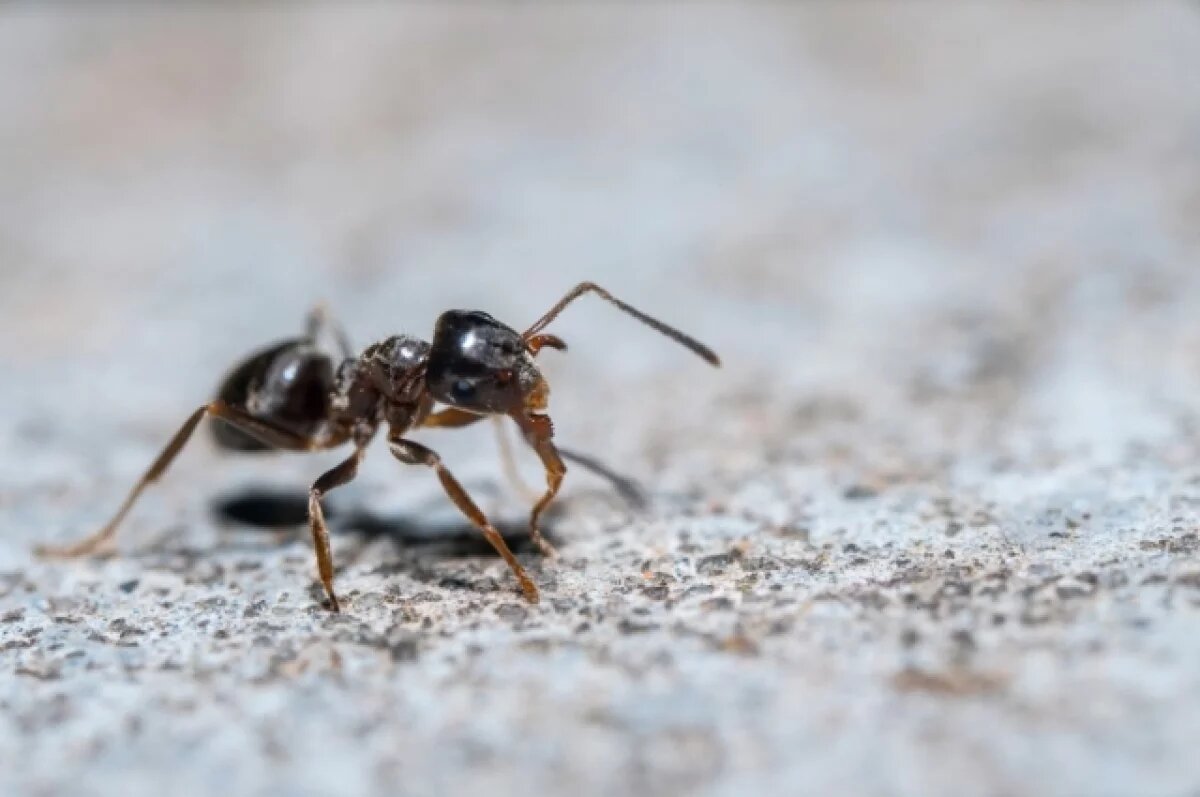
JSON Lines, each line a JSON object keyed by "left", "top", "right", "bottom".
{"left": 425, "top": 310, "right": 544, "bottom": 413}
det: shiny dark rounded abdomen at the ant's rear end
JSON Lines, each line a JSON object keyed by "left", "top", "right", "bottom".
{"left": 211, "top": 337, "right": 334, "bottom": 451}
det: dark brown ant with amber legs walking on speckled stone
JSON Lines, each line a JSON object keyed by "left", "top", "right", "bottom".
{"left": 38, "top": 282, "right": 720, "bottom": 612}
